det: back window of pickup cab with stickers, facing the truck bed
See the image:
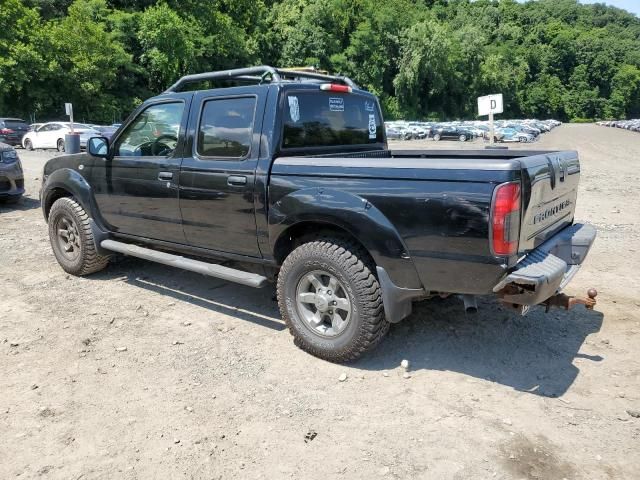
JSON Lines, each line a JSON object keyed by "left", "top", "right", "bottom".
{"left": 282, "top": 91, "right": 383, "bottom": 149}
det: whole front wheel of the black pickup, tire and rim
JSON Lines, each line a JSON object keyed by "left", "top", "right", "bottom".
{"left": 49, "top": 197, "right": 109, "bottom": 275}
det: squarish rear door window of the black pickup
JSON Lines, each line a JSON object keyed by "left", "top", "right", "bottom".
{"left": 197, "top": 97, "right": 256, "bottom": 159}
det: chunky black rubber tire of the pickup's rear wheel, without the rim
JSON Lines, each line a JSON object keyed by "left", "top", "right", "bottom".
{"left": 277, "top": 238, "right": 389, "bottom": 362}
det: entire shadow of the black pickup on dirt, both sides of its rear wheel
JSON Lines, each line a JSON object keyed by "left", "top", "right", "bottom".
{"left": 92, "top": 257, "right": 603, "bottom": 397}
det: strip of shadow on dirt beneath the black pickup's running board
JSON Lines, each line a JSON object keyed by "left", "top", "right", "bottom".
{"left": 92, "top": 257, "right": 286, "bottom": 330}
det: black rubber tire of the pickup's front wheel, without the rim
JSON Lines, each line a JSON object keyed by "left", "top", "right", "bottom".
{"left": 48, "top": 197, "right": 109, "bottom": 276}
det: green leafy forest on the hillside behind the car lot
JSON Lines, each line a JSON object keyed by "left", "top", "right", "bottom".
{"left": 0, "top": 0, "right": 640, "bottom": 122}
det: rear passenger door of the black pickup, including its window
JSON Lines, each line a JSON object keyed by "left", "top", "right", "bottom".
{"left": 180, "top": 88, "right": 266, "bottom": 257}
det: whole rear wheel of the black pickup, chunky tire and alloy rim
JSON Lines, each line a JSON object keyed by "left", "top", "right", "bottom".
{"left": 277, "top": 238, "right": 389, "bottom": 362}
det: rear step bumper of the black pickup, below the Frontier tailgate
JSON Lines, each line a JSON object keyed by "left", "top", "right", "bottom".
{"left": 493, "top": 224, "right": 596, "bottom": 305}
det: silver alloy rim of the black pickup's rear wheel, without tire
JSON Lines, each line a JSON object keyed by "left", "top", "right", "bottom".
{"left": 296, "top": 270, "right": 352, "bottom": 337}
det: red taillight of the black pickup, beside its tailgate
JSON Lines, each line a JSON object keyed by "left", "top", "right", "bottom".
{"left": 491, "top": 182, "right": 520, "bottom": 255}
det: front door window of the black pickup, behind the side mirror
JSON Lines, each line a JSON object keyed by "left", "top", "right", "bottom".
{"left": 115, "top": 102, "right": 184, "bottom": 157}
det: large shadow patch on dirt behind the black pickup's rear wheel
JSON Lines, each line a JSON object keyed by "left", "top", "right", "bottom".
{"left": 357, "top": 297, "right": 603, "bottom": 397}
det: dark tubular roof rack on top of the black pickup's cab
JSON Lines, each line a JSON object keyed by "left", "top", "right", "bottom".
{"left": 165, "top": 65, "right": 358, "bottom": 93}
